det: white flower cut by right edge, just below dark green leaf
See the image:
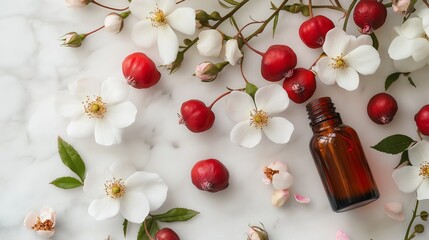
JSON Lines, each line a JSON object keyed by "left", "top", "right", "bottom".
{"left": 392, "top": 141, "right": 429, "bottom": 200}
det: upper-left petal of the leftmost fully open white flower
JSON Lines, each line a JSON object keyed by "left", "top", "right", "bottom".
{"left": 69, "top": 78, "right": 101, "bottom": 101}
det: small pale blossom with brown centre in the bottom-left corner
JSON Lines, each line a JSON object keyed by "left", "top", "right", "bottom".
{"left": 24, "top": 208, "right": 56, "bottom": 238}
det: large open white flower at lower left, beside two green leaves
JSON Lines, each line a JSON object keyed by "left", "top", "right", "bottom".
{"left": 83, "top": 162, "right": 168, "bottom": 223}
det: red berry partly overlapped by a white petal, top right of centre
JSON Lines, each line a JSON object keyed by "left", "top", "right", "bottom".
{"left": 299, "top": 15, "right": 335, "bottom": 48}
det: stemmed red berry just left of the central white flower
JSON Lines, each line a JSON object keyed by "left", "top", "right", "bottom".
{"left": 179, "top": 99, "right": 215, "bottom": 133}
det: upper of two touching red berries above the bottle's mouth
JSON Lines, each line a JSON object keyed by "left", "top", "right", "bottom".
{"left": 261, "top": 45, "right": 297, "bottom": 82}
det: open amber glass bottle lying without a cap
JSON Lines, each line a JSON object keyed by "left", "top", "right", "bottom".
{"left": 307, "top": 97, "right": 380, "bottom": 212}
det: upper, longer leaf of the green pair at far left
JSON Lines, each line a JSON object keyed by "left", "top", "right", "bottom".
{"left": 58, "top": 137, "right": 85, "bottom": 182}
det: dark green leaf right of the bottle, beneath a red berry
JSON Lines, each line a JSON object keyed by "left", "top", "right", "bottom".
{"left": 372, "top": 134, "right": 416, "bottom": 154}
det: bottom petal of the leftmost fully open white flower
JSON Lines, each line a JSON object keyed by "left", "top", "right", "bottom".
{"left": 94, "top": 120, "right": 122, "bottom": 146}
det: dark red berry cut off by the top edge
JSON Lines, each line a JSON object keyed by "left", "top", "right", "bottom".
{"left": 353, "top": 0, "right": 387, "bottom": 34}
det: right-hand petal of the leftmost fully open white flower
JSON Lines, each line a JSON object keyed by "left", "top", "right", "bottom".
{"left": 104, "top": 101, "right": 137, "bottom": 128}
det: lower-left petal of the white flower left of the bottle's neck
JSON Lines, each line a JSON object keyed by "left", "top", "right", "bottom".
{"left": 230, "top": 120, "right": 262, "bottom": 148}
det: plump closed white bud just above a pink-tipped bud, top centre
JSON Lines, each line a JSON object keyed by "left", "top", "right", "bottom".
{"left": 197, "top": 29, "right": 223, "bottom": 57}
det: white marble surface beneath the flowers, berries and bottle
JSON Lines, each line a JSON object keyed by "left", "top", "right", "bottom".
{"left": 0, "top": 0, "right": 429, "bottom": 240}
